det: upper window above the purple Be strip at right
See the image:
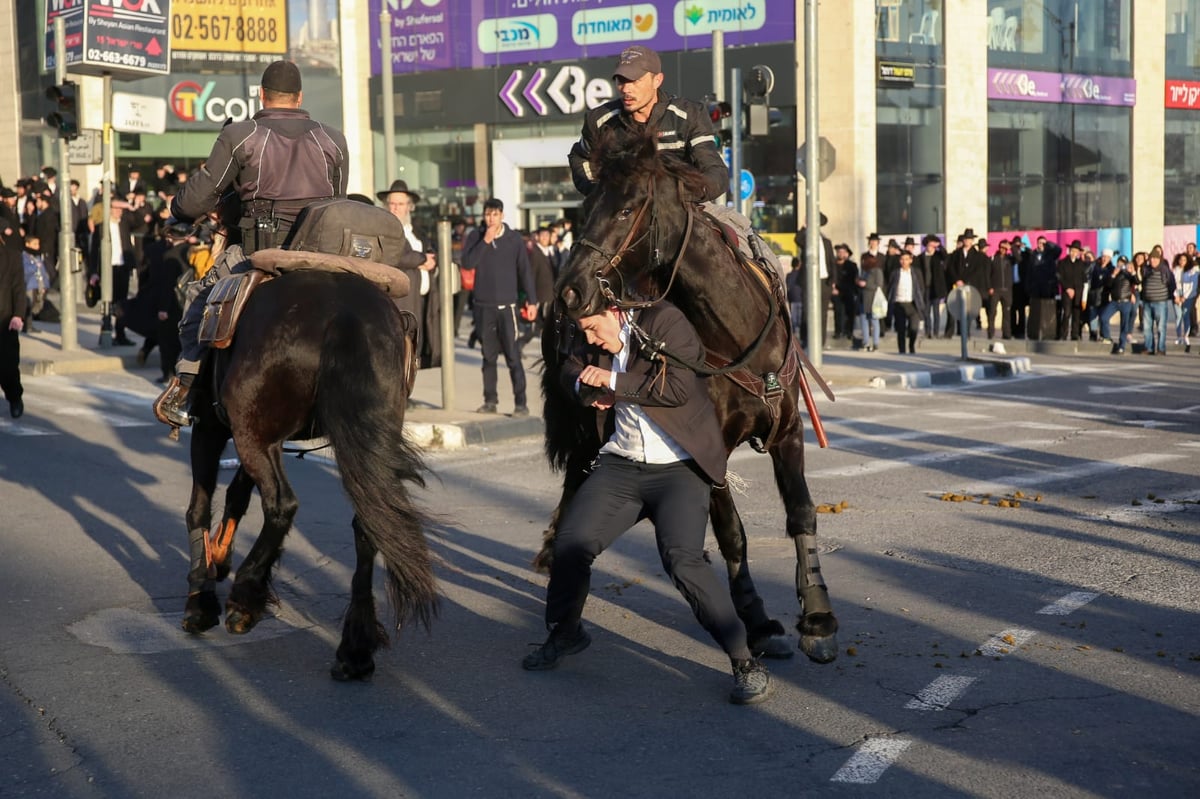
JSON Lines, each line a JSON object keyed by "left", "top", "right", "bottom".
{"left": 988, "top": 0, "right": 1133, "bottom": 77}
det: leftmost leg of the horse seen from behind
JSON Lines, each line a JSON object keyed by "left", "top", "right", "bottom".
{"left": 182, "top": 415, "right": 229, "bottom": 632}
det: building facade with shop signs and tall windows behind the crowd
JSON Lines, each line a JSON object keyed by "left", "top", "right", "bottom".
{"left": 9, "top": 0, "right": 1200, "bottom": 252}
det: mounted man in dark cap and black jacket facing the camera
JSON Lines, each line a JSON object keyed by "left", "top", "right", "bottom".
{"left": 568, "top": 44, "right": 730, "bottom": 202}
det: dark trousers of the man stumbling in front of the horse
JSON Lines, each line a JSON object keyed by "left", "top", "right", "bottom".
{"left": 546, "top": 453, "right": 750, "bottom": 660}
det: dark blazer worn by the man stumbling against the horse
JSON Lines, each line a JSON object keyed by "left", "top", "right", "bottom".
{"left": 559, "top": 301, "right": 727, "bottom": 485}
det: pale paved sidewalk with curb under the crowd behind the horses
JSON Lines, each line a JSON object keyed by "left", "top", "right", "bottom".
{"left": 20, "top": 299, "right": 1051, "bottom": 449}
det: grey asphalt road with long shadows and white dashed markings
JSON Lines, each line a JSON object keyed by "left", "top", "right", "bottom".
{"left": 0, "top": 356, "right": 1200, "bottom": 799}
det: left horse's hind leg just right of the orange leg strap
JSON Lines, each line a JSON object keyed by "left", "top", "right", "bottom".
{"left": 226, "top": 439, "right": 299, "bottom": 635}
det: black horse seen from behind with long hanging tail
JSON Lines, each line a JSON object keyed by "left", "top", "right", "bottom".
{"left": 182, "top": 271, "right": 437, "bottom": 679}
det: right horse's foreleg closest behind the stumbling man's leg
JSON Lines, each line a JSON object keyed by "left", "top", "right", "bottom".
{"left": 708, "top": 486, "right": 792, "bottom": 657}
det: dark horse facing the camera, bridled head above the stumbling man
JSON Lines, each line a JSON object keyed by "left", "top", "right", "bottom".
{"left": 535, "top": 125, "right": 838, "bottom": 662}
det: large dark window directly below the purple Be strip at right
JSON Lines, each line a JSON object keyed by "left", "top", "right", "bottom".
{"left": 988, "top": 101, "right": 1133, "bottom": 230}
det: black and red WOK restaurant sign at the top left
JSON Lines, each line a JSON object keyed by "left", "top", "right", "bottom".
{"left": 46, "top": 0, "right": 170, "bottom": 80}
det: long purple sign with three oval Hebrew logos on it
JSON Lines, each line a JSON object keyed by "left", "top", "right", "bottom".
{"left": 367, "top": 0, "right": 796, "bottom": 74}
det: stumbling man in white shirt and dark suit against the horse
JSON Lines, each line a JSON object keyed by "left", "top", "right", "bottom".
{"left": 522, "top": 301, "right": 770, "bottom": 704}
